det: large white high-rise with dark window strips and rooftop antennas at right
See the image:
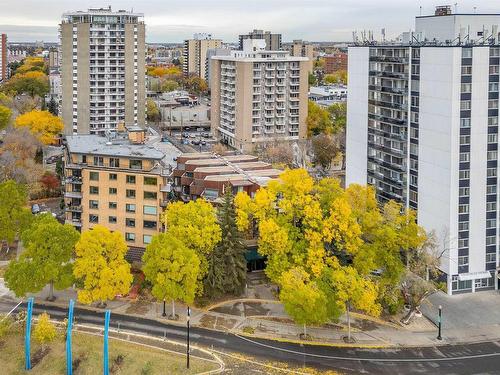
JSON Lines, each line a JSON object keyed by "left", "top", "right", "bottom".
{"left": 346, "top": 7, "right": 500, "bottom": 294}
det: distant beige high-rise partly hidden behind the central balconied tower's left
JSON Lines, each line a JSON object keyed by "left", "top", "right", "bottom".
{"left": 182, "top": 34, "right": 222, "bottom": 79}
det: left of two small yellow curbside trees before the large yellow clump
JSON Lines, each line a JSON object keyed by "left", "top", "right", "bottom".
{"left": 280, "top": 267, "right": 328, "bottom": 336}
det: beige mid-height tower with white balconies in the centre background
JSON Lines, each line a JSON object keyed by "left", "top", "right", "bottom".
{"left": 211, "top": 39, "right": 309, "bottom": 152}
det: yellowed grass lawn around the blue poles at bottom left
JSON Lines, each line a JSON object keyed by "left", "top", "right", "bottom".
{"left": 0, "top": 326, "right": 218, "bottom": 375}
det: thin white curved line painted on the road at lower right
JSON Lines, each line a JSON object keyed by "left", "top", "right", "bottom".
{"left": 234, "top": 334, "right": 500, "bottom": 362}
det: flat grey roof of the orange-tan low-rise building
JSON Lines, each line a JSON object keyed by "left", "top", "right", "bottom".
{"left": 66, "top": 134, "right": 164, "bottom": 160}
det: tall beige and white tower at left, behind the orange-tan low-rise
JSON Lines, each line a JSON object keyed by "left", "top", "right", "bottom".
{"left": 60, "top": 7, "right": 146, "bottom": 135}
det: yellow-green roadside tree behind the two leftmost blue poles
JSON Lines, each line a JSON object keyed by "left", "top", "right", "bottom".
{"left": 5, "top": 214, "right": 80, "bottom": 301}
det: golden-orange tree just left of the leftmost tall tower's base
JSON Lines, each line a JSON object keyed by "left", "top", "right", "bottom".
{"left": 15, "top": 110, "right": 64, "bottom": 145}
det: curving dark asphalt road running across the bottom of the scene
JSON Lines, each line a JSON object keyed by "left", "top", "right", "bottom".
{"left": 0, "top": 301, "right": 500, "bottom": 374}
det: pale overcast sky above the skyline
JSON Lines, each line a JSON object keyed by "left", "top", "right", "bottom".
{"left": 0, "top": 0, "right": 500, "bottom": 43}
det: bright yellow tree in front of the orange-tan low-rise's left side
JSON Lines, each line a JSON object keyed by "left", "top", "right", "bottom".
{"left": 73, "top": 225, "right": 132, "bottom": 305}
